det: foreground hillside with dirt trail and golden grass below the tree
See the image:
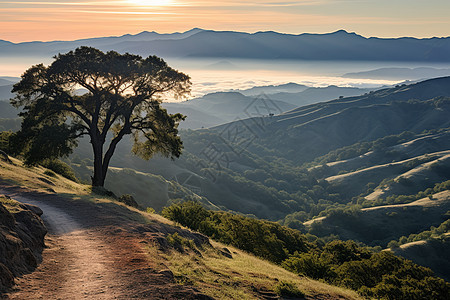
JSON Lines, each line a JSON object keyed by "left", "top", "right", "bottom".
{"left": 0, "top": 159, "right": 360, "bottom": 299}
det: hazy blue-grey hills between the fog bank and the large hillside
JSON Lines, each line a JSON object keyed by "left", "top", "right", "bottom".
{"left": 163, "top": 83, "right": 371, "bottom": 129}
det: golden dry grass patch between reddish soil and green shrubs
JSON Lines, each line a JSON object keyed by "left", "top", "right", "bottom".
{"left": 153, "top": 242, "right": 363, "bottom": 299}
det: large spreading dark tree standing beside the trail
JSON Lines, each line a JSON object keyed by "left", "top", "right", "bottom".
{"left": 11, "top": 47, "right": 191, "bottom": 186}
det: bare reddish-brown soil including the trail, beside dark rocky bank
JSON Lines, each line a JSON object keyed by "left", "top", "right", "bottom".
{"left": 0, "top": 183, "right": 209, "bottom": 300}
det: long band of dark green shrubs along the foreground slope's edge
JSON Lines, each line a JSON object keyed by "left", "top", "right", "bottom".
{"left": 163, "top": 201, "right": 450, "bottom": 300}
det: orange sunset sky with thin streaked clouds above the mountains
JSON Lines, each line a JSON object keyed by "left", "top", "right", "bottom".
{"left": 0, "top": 0, "right": 450, "bottom": 43}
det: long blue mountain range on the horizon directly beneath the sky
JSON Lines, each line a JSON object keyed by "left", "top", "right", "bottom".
{"left": 0, "top": 29, "right": 450, "bottom": 62}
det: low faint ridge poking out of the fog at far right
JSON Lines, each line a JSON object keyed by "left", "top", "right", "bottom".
{"left": 342, "top": 67, "right": 450, "bottom": 80}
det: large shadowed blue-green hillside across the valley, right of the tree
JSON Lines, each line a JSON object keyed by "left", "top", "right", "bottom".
{"left": 55, "top": 78, "right": 450, "bottom": 226}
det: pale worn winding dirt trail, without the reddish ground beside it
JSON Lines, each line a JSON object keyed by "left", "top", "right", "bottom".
{"left": 10, "top": 196, "right": 125, "bottom": 299}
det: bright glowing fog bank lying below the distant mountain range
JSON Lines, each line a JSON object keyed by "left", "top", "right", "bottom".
{"left": 0, "top": 57, "right": 450, "bottom": 97}
